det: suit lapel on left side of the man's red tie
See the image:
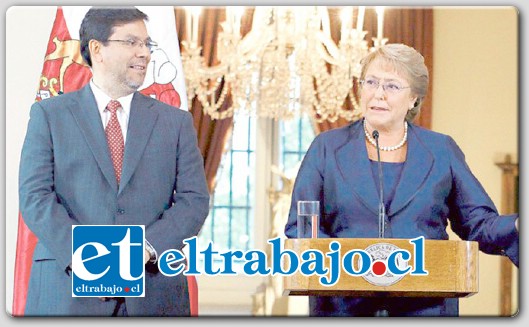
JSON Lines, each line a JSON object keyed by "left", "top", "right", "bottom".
{"left": 68, "top": 85, "right": 118, "bottom": 192}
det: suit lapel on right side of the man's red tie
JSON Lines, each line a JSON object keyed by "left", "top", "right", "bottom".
{"left": 119, "top": 92, "right": 158, "bottom": 193}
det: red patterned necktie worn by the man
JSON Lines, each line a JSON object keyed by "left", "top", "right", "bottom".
{"left": 105, "top": 100, "right": 125, "bottom": 185}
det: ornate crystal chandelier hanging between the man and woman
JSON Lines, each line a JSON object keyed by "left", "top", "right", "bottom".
{"left": 182, "top": 6, "right": 387, "bottom": 122}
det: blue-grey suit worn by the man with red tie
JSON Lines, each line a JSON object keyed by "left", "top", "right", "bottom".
{"left": 19, "top": 85, "right": 209, "bottom": 316}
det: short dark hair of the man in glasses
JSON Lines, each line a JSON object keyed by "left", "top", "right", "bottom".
{"left": 79, "top": 7, "right": 149, "bottom": 67}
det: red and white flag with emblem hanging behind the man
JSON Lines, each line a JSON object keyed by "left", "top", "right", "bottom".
{"left": 12, "top": 6, "right": 193, "bottom": 316}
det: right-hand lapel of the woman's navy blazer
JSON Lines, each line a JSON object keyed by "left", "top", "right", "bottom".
{"left": 388, "top": 124, "right": 434, "bottom": 216}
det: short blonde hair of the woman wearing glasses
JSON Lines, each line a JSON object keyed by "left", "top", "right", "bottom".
{"left": 360, "top": 43, "right": 429, "bottom": 122}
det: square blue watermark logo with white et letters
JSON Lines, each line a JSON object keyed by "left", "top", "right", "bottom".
{"left": 71, "top": 225, "right": 145, "bottom": 297}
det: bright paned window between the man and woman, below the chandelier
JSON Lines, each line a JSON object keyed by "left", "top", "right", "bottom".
{"left": 199, "top": 113, "right": 314, "bottom": 252}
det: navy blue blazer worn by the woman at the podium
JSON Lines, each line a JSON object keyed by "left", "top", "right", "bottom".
{"left": 285, "top": 120, "right": 518, "bottom": 315}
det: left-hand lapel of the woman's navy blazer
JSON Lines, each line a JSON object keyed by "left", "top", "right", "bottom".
{"left": 335, "top": 120, "right": 379, "bottom": 217}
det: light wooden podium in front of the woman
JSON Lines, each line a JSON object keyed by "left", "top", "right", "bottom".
{"left": 283, "top": 238, "right": 478, "bottom": 297}
